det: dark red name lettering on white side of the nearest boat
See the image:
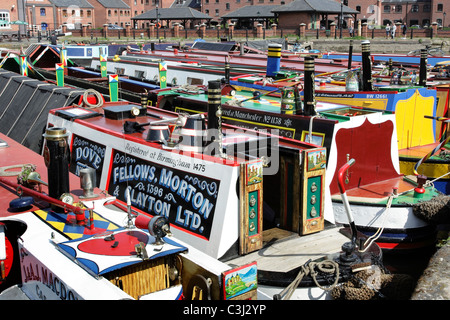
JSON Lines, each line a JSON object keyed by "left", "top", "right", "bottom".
{"left": 22, "top": 262, "right": 77, "bottom": 300}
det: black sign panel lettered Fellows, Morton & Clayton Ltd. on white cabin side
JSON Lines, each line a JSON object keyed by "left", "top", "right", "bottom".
{"left": 108, "top": 149, "right": 220, "bottom": 238}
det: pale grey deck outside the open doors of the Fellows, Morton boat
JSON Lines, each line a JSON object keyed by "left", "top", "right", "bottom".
{"left": 226, "top": 227, "right": 349, "bottom": 272}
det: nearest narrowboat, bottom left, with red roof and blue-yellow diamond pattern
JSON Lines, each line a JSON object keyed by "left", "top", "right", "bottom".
{"left": 0, "top": 132, "right": 257, "bottom": 300}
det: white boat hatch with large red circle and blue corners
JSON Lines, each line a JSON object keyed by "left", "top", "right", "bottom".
{"left": 57, "top": 228, "right": 187, "bottom": 299}
